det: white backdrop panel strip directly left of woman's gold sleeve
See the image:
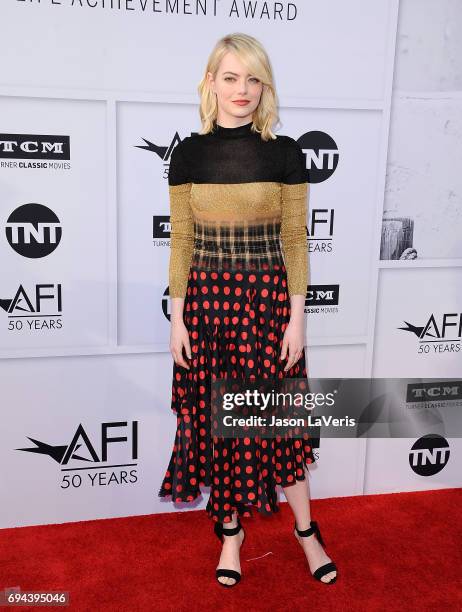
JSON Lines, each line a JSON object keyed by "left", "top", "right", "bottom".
{"left": 117, "top": 103, "right": 200, "bottom": 347}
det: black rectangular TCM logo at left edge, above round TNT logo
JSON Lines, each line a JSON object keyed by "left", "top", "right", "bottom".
{"left": 0, "top": 134, "right": 70, "bottom": 160}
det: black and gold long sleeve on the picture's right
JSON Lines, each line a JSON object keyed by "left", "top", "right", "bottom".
{"left": 281, "top": 139, "right": 308, "bottom": 296}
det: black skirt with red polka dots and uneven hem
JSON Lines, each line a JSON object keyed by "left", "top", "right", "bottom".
{"left": 158, "top": 265, "right": 315, "bottom": 523}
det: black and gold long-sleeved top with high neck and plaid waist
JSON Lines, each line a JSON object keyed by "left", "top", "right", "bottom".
{"left": 168, "top": 122, "right": 308, "bottom": 298}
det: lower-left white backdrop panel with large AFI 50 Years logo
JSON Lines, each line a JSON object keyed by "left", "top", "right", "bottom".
{"left": 0, "top": 354, "right": 176, "bottom": 527}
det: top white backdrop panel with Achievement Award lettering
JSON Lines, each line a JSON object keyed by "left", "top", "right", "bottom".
{"left": 0, "top": 0, "right": 395, "bottom": 100}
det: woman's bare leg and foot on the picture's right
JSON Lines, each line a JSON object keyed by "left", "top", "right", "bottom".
{"left": 283, "top": 466, "right": 337, "bottom": 582}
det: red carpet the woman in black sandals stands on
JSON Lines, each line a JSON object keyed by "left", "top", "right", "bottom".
{"left": 0, "top": 489, "right": 462, "bottom": 612}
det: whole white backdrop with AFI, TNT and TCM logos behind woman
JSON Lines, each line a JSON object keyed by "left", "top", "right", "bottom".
{"left": 0, "top": 0, "right": 462, "bottom": 527}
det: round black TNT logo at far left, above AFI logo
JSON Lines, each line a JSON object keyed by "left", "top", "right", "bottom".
{"left": 5, "top": 204, "right": 62, "bottom": 259}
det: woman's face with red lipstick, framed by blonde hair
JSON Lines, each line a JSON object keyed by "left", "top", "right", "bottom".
{"left": 207, "top": 52, "right": 263, "bottom": 127}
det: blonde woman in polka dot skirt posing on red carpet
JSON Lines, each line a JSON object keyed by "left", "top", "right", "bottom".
{"left": 159, "top": 34, "right": 336, "bottom": 587}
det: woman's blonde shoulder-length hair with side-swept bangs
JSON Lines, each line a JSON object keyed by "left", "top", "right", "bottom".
{"left": 198, "top": 32, "right": 279, "bottom": 141}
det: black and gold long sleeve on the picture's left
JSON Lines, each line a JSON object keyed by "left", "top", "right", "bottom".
{"left": 168, "top": 143, "right": 194, "bottom": 298}
